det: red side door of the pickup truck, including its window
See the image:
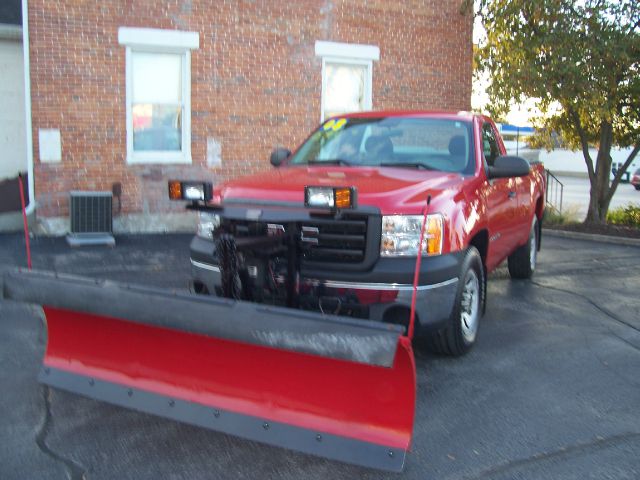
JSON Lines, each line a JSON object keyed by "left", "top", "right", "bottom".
{"left": 482, "top": 122, "right": 519, "bottom": 269}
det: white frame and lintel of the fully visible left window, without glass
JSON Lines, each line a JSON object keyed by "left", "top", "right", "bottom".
{"left": 118, "top": 27, "right": 200, "bottom": 164}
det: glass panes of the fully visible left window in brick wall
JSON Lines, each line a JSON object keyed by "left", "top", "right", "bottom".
{"left": 131, "top": 52, "right": 183, "bottom": 151}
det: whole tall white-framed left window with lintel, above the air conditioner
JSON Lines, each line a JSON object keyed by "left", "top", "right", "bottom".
{"left": 118, "top": 27, "right": 199, "bottom": 163}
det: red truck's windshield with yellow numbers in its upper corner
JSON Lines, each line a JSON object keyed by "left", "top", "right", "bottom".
{"left": 290, "top": 117, "right": 475, "bottom": 174}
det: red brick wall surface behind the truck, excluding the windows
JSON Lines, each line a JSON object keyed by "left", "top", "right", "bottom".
{"left": 29, "top": 0, "right": 472, "bottom": 224}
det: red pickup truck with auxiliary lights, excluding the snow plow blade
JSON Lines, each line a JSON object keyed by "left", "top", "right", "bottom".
{"left": 180, "top": 112, "right": 545, "bottom": 355}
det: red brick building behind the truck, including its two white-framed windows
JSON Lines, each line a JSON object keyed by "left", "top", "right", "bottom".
{"left": 27, "top": 0, "right": 472, "bottom": 233}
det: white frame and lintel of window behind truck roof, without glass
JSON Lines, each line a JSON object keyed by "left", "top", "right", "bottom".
{"left": 315, "top": 40, "right": 380, "bottom": 122}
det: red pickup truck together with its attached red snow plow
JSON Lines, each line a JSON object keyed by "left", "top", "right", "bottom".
{"left": 2, "top": 112, "right": 545, "bottom": 471}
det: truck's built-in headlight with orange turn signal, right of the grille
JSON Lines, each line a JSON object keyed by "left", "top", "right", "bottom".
{"left": 380, "top": 213, "right": 444, "bottom": 257}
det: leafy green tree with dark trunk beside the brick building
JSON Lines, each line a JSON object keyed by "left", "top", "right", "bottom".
{"left": 467, "top": 0, "right": 640, "bottom": 223}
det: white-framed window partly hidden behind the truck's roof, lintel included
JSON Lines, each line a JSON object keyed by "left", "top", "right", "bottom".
{"left": 315, "top": 41, "right": 380, "bottom": 121}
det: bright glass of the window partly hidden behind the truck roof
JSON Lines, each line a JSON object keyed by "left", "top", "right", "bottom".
{"left": 323, "top": 62, "right": 368, "bottom": 118}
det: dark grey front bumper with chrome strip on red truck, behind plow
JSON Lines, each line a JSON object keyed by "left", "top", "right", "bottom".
{"left": 190, "top": 237, "right": 463, "bottom": 331}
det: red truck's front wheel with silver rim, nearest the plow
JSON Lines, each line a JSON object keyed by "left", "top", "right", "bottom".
{"left": 425, "top": 247, "right": 486, "bottom": 357}
